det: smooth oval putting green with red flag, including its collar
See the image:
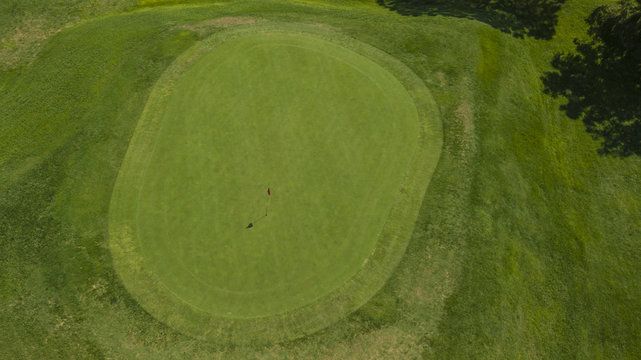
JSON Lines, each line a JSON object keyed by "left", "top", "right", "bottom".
{"left": 110, "top": 27, "right": 440, "bottom": 340}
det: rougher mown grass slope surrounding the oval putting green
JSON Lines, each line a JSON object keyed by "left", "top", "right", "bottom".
{"left": 0, "top": 0, "right": 641, "bottom": 359}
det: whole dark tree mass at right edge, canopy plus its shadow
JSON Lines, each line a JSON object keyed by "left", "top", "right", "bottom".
{"left": 543, "top": 0, "right": 641, "bottom": 157}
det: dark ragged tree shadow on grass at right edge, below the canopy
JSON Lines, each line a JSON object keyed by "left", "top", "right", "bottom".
{"left": 542, "top": 40, "right": 641, "bottom": 157}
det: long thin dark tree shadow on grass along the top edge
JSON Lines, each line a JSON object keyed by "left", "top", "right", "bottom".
{"left": 376, "top": 0, "right": 566, "bottom": 39}
